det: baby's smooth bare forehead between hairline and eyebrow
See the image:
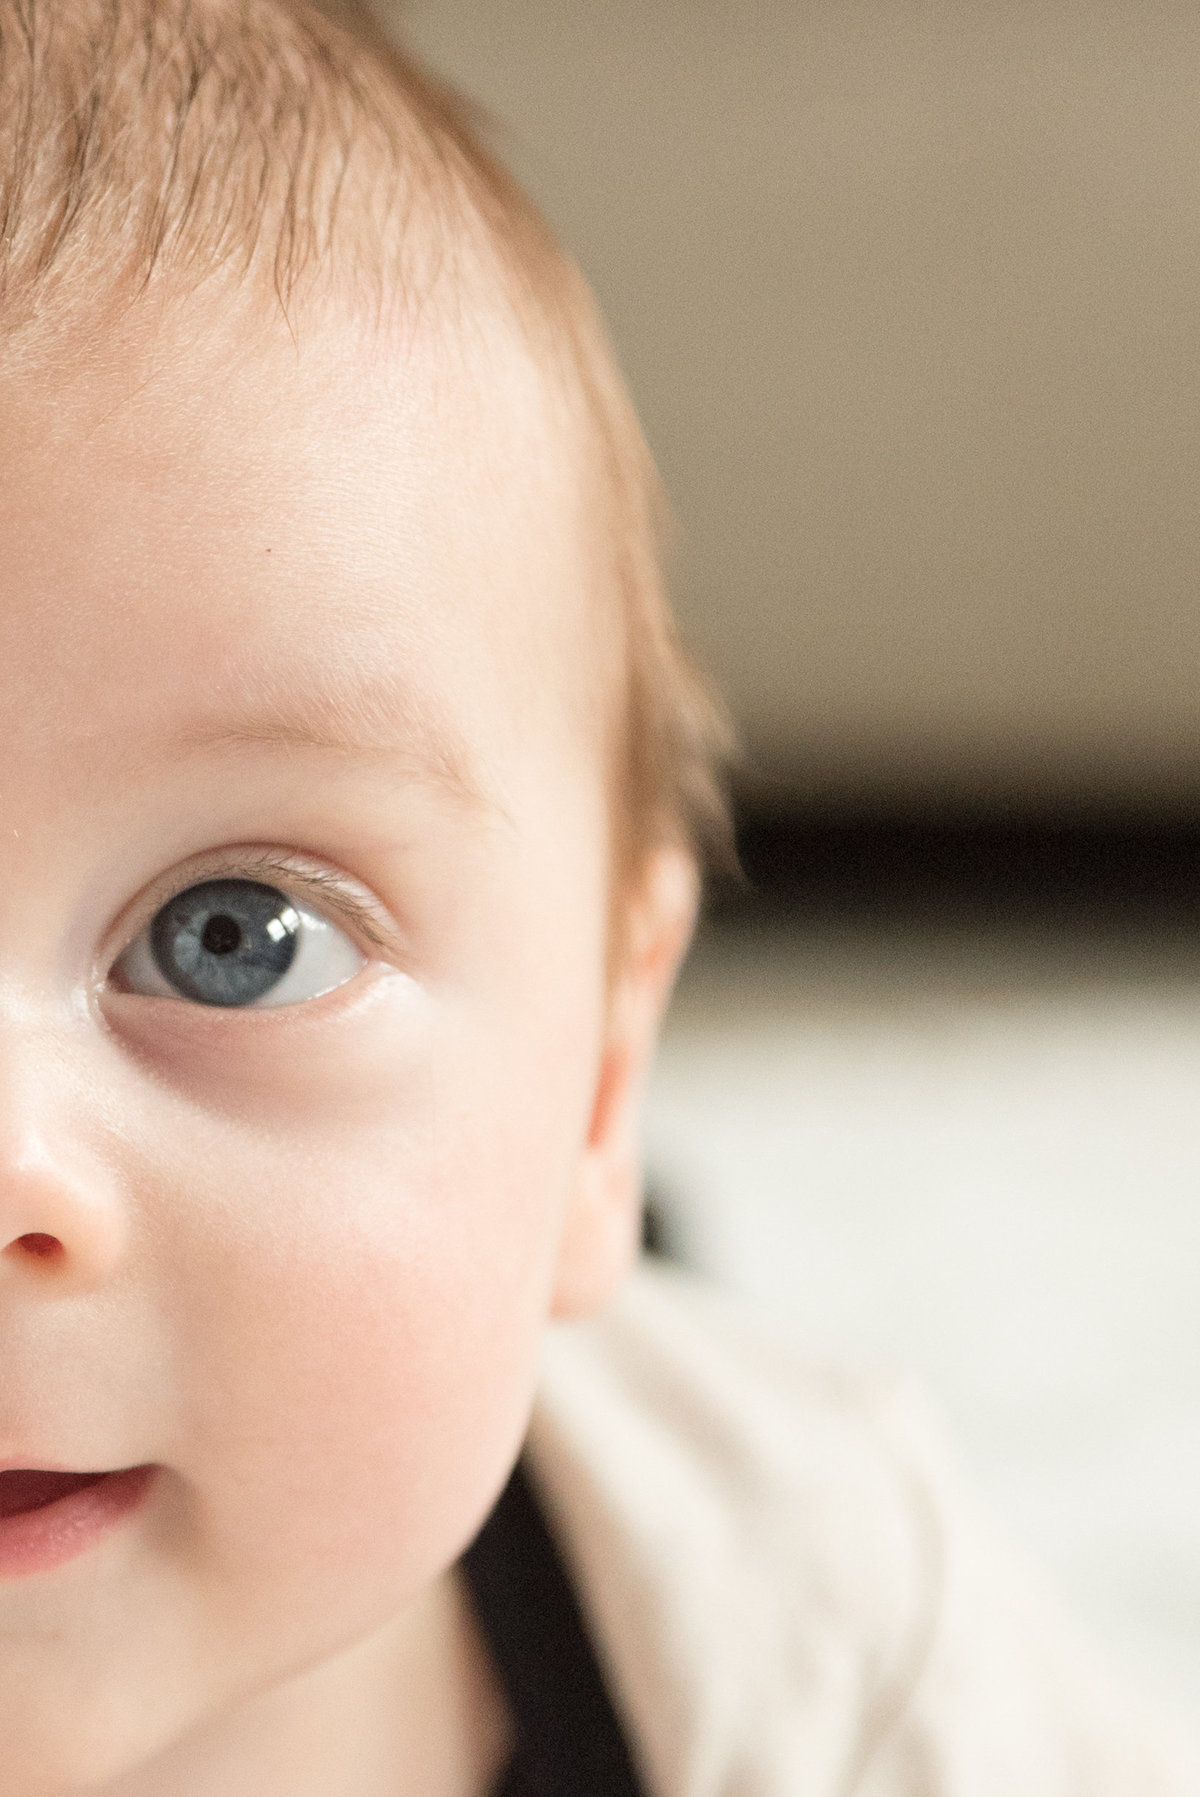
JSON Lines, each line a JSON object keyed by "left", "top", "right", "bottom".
{"left": 0, "top": 276, "right": 593, "bottom": 789}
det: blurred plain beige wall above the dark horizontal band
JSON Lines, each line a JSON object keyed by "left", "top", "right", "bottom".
{"left": 400, "top": 0, "right": 1200, "bottom": 805}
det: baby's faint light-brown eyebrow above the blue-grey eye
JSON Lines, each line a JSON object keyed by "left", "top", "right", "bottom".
{"left": 167, "top": 679, "right": 499, "bottom": 809}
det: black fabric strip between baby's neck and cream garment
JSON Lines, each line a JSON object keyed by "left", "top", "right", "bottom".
{"left": 462, "top": 1461, "right": 647, "bottom": 1797}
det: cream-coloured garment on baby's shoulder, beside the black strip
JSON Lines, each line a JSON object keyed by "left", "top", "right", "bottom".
{"left": 530, "top": 1267, "right": 1200, "bottom": 1797}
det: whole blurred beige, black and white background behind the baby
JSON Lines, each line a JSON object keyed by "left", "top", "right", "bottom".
{"left": 400, "top": 0, "right": 1200, "bottom": 1718}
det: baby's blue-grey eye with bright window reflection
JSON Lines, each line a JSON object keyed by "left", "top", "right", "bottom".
{"left": 113, "top": 879, "right": 365, "bottom": 1006}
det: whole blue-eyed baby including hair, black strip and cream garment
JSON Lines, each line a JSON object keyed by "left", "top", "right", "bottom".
{"left": 0, "top": 0, "right": 1200, "bottom": 1797}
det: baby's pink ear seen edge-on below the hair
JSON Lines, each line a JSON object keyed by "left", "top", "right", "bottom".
{"left": 551, "top": 848, "right": 701, "bottom": 1317}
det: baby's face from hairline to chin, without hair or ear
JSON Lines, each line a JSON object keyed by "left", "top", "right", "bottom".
{"left": 0, "top": 291, "right": 646, "bottom": 1792}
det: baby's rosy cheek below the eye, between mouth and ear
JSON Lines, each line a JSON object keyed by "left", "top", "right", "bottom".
{"left": 146, "top": 1006, "right": 578, "bottom": 1639}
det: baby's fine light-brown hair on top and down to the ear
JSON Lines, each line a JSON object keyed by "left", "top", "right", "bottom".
{"left": 0, "top": 0, "right": 731, "bottom": 894}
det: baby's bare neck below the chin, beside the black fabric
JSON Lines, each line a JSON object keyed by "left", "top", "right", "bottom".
{"left": 97, "top": 1571, "right": 512, "bottom": 1797}
